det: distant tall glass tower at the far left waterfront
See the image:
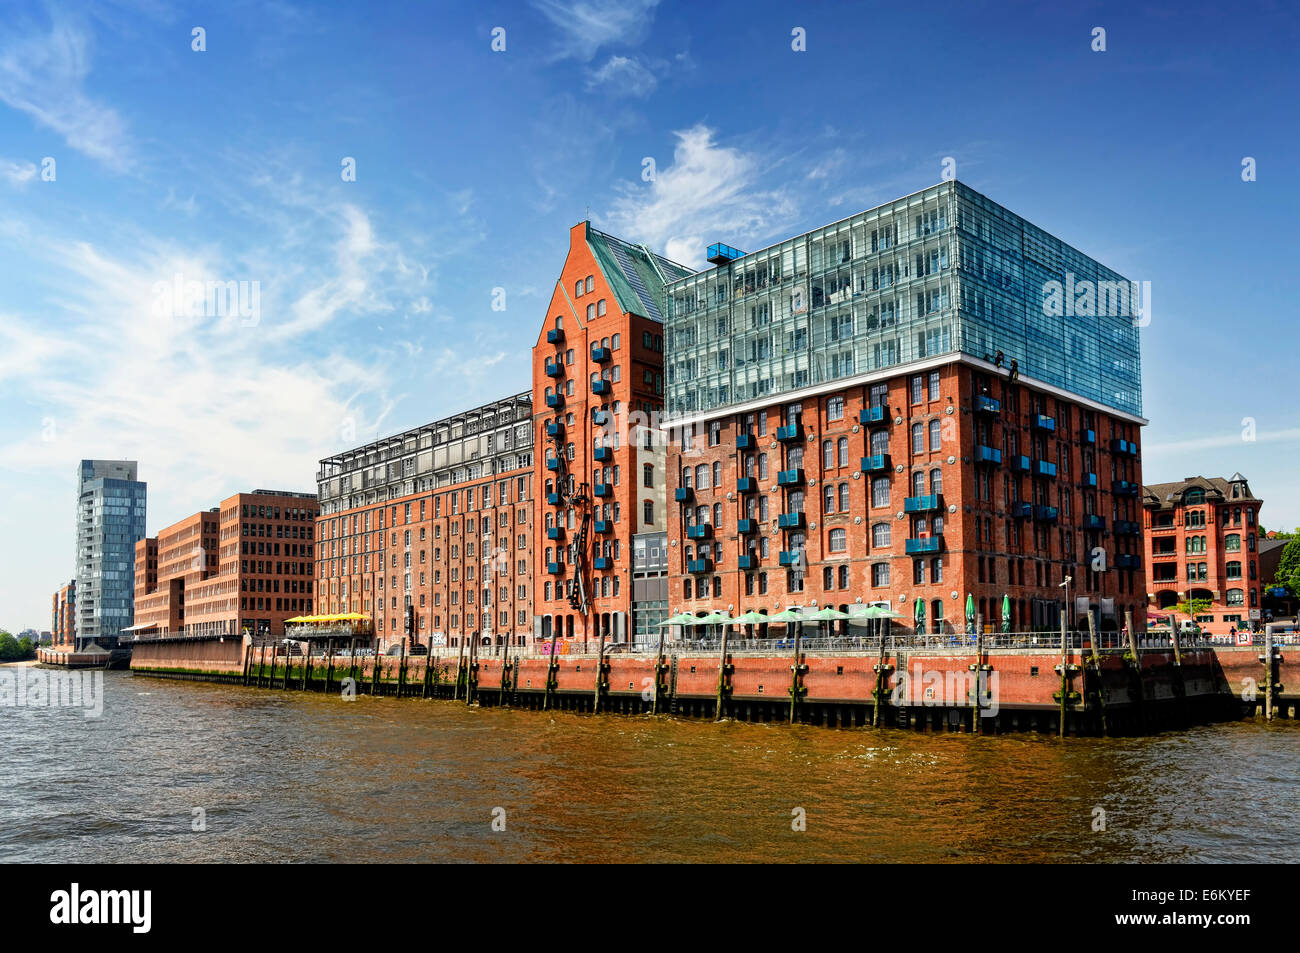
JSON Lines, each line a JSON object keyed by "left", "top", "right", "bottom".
{"left": 75, "top": 460, "right": 147, "bottom": 649}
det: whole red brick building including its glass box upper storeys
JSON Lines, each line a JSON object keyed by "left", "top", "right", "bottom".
{"left": 664, "top": 182, "right": 1147, "bottom": 632}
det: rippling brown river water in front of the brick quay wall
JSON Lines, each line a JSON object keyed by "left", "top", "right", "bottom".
{"left": 0, "top": 672, "right": 1300, "bottom": 862}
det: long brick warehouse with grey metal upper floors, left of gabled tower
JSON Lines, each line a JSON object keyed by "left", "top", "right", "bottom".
{"left": 316, "top": 391, "right": 534, "bottom": 649}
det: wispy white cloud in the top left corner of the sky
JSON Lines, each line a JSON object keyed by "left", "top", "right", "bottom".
{"left": 0, "top": 13, "right": 133, "bottom": 170}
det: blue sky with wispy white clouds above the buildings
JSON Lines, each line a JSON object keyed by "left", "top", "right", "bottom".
{"left": 0, "top": 0, "right": 1300, "bottom": 629}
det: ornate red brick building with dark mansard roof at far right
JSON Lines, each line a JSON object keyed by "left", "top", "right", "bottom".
{"left": 1141, "top": 473, "right": 1268, "bottom": 636}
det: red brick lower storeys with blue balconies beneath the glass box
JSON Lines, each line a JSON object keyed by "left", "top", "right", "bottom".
{"left": 668, "top": 355, "right": 1145, "bottom": 632}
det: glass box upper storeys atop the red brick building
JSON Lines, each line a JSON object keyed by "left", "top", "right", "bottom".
{"left": 664, "top": 181, "right": 1141, "bottom": 419}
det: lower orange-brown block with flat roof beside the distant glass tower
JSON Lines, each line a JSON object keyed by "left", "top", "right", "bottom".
{"left": 127, "top": 490, "right": 317, "bottom": 638}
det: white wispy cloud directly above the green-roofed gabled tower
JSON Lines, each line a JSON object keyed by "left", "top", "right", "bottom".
{"left": 607, "top": 125, "right": 796, "bottom": 265}
